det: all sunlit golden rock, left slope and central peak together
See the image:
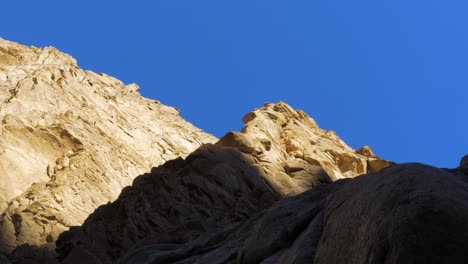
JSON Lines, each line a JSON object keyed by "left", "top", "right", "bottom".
{"left": 0, "top": 40, "right": 388, "bottom": 258}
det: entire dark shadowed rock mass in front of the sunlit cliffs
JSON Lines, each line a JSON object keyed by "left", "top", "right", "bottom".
{"left": 57, "top": 145, "right": 468, "bottom": 264}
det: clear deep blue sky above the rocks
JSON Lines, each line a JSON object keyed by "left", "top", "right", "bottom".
{"left": 0, "top": 0, "right": 468, "bottom": 167}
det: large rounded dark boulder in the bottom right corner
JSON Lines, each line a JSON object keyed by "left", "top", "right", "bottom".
{"left": 314, "top": 164, "right": 468, "bottom": 264}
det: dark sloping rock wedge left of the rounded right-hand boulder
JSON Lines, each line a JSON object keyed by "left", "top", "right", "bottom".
{"left": 119, "top": 184, "right": 339, "bottom": 264}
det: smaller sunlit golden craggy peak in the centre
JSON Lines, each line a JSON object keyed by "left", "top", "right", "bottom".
{"left": 217, "top": 102, "right": 393, "bottom": 196}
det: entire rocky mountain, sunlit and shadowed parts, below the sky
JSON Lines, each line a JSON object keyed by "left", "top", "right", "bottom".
{"left": 0, "top": 39, "right": 468, "bottom": 264}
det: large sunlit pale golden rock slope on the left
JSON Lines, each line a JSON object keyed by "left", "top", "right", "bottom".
{"left": 0, "top": 39, "right": 216, "bottom": 258}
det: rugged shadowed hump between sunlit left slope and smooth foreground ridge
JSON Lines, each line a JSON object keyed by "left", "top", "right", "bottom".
{"left": 56, "top": 144, "right": 330, "bottom": 263}
